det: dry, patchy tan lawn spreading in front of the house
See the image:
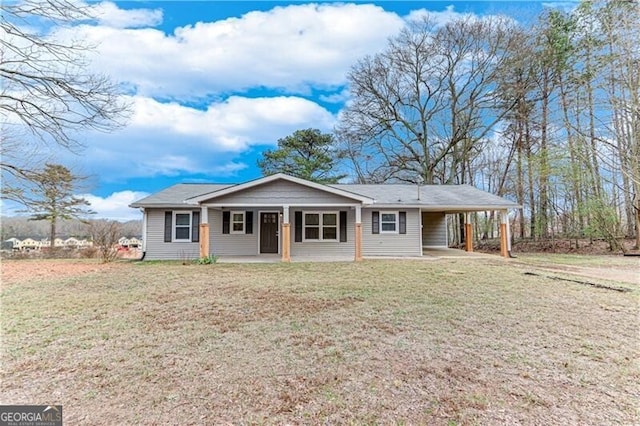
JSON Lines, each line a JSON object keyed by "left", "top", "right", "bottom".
{"left": 0, "top": 258, "right": 640, "bottom": 425}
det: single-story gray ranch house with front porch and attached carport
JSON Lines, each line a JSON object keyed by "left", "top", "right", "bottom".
{"left": 131, "top": 174, "right": 519, "bottom": 262}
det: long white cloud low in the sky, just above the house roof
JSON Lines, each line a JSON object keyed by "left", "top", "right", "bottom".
{"left": 66, "top": 96, "right": 335, "bottom": 182}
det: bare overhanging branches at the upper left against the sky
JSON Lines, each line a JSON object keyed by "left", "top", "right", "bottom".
{"left": 0, "top": 0, "right": 129, "bottom": 201}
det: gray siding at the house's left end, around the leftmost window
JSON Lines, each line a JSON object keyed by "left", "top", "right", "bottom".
{"left": 145, "top": 209, "right": 200, "bottom": 260}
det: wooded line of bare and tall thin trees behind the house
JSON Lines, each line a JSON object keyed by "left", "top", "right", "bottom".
{"left": 336, "top": 1, "right": 640, "bottom": 248}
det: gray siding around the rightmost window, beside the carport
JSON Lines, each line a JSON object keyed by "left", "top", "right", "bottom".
{"left": 362, "top": 208, "right": 422, "bottom": 256}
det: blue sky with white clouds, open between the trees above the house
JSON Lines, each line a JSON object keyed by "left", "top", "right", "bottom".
{"left": 5, "top": 1, "right": 558, "bottom": 220}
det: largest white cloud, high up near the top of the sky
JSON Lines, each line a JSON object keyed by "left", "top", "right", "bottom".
{"left": 57, "top": 3, "right": 403, "bottom": 99}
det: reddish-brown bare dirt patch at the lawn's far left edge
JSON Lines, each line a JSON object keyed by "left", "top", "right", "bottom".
{"left": 0, "top": 260, "right": 124, "bottom": 286}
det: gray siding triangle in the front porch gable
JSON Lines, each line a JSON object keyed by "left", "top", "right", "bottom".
{"left": 204, "top": 180, "right": 355, "bottom": 205}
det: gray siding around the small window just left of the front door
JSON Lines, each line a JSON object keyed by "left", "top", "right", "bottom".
{"left": 209, "top": 208, "right": 262, "bottom": 256}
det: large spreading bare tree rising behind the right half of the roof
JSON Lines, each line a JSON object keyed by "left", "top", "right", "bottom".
{"left": 337, "top": 18, "right": 514, "bottom": 183}
